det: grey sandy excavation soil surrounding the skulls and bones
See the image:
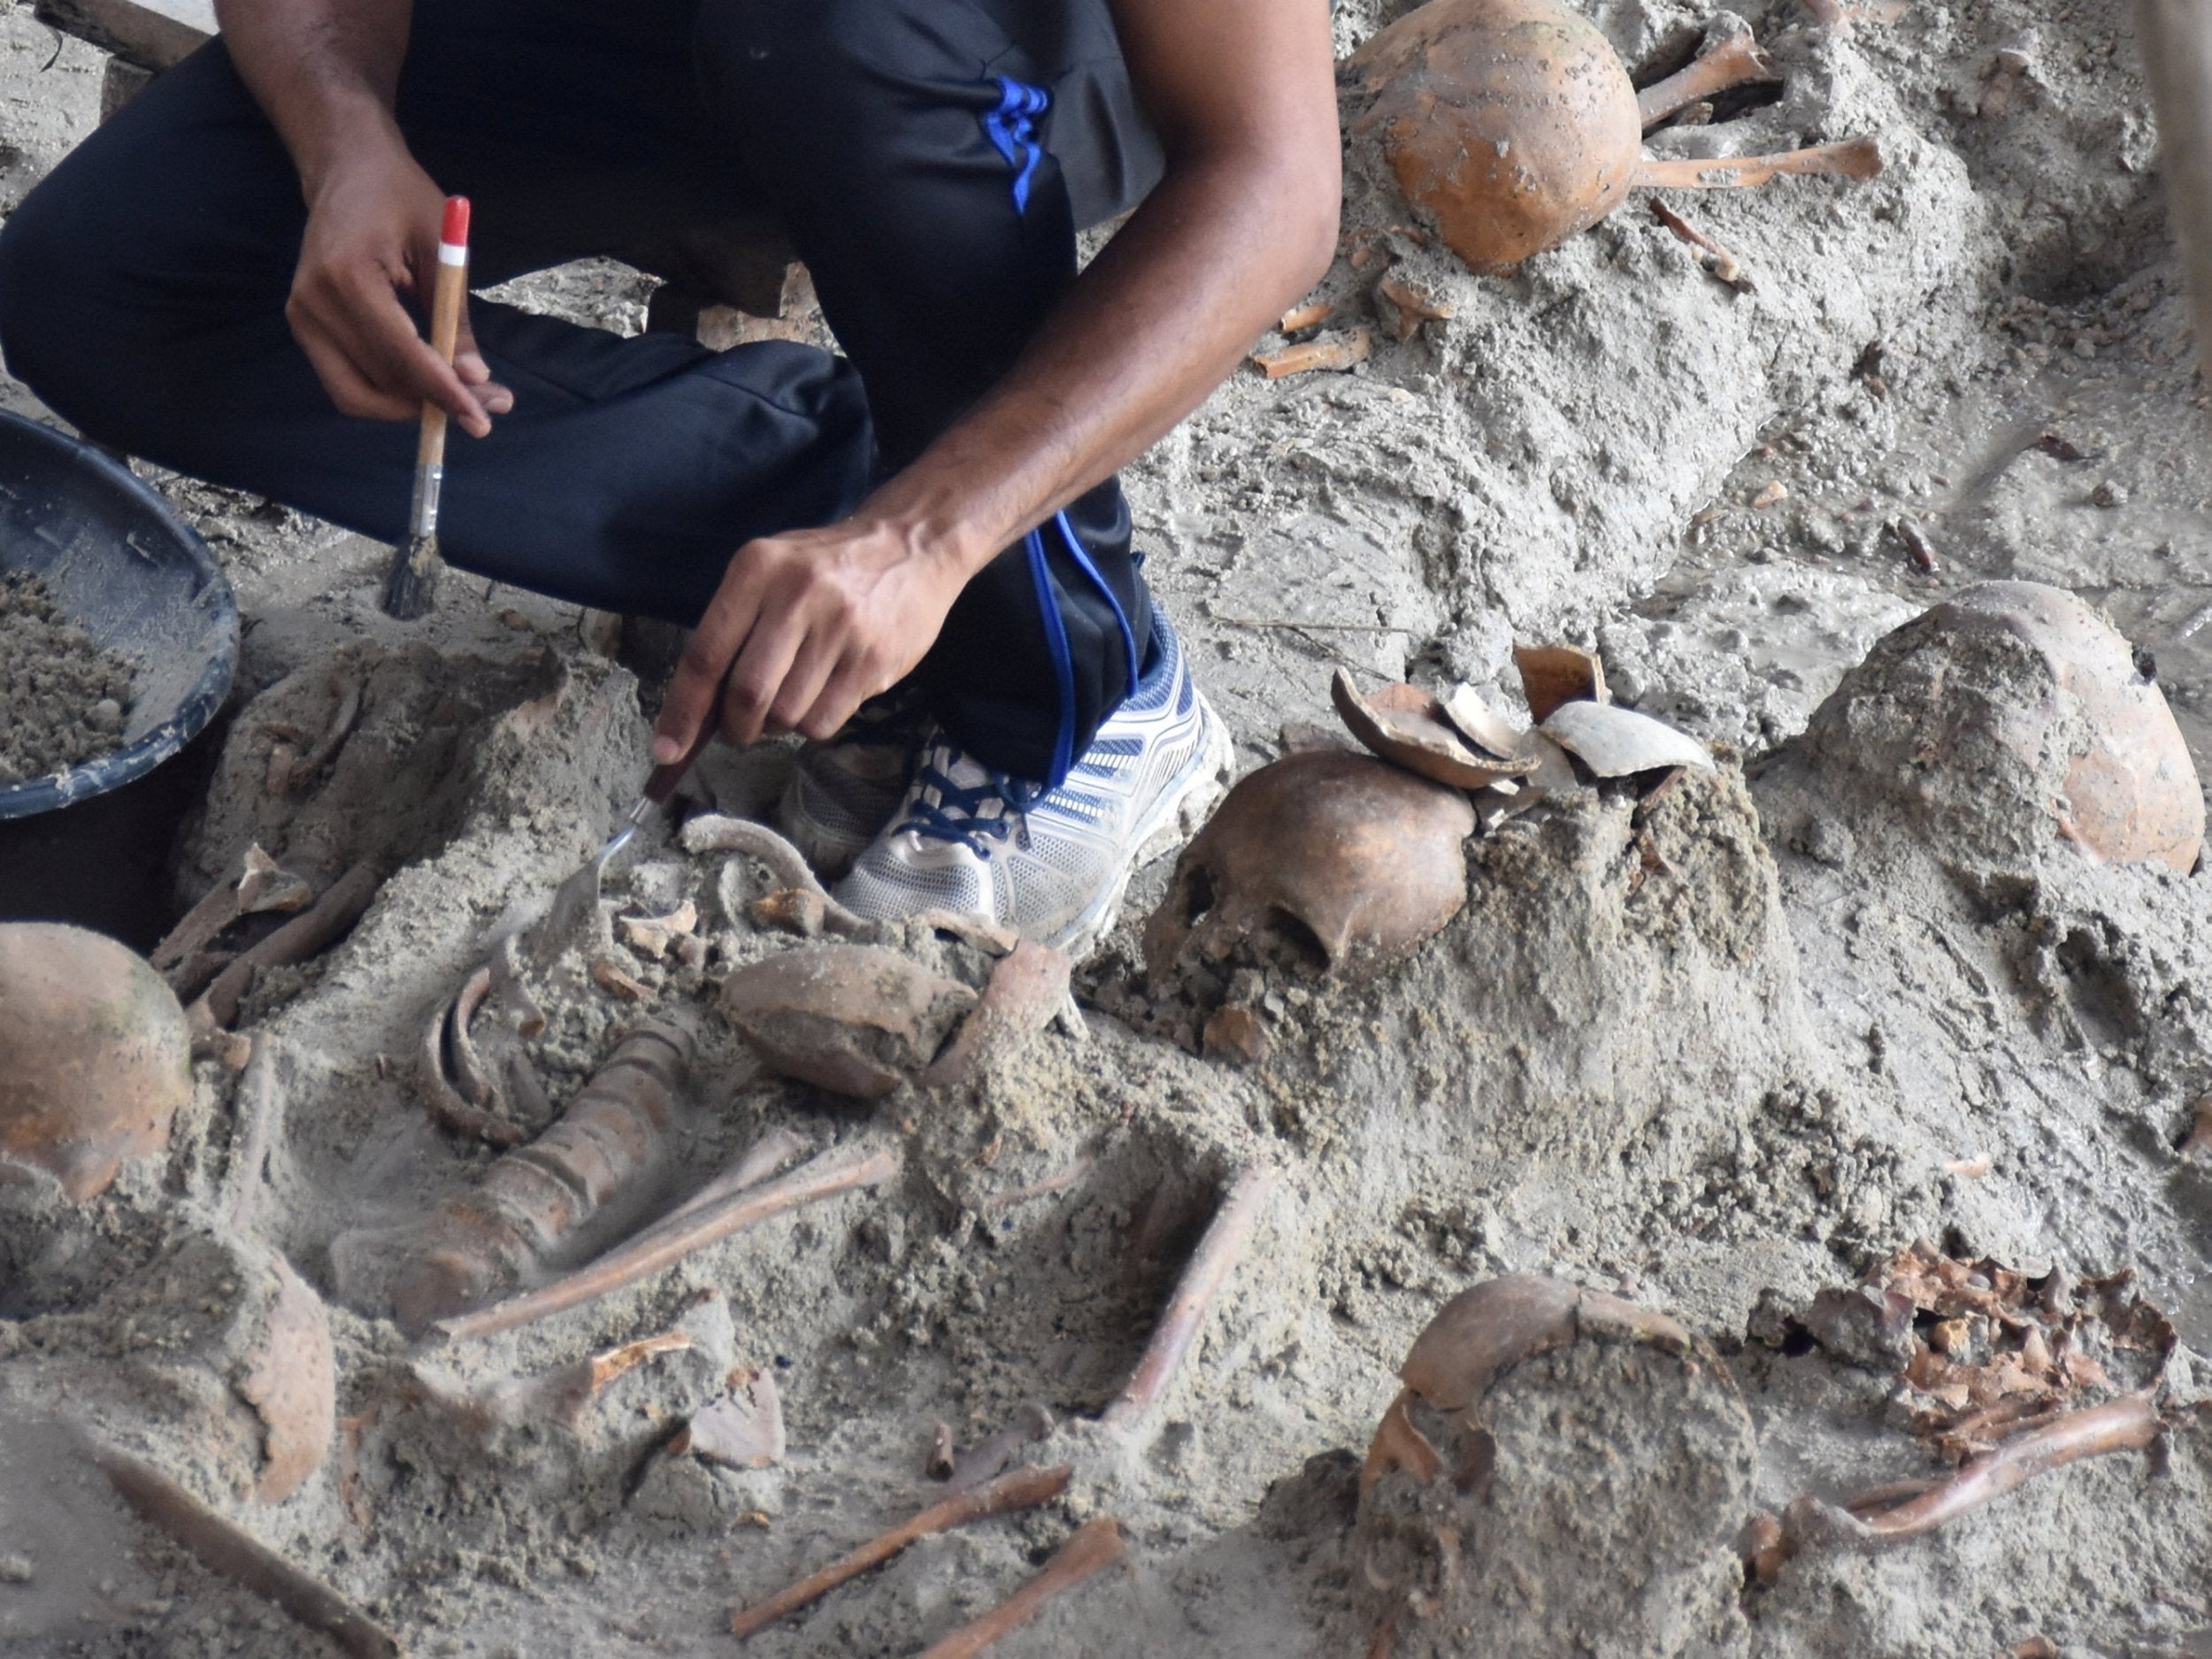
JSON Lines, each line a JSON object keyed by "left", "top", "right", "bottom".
{"left": 0, "top": 0, "right": 2212, "bottom": 1659}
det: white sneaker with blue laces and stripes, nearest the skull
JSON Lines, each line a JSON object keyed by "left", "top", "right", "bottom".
{"left": 836, "top": 611, "right": 1234, "bottom": 958}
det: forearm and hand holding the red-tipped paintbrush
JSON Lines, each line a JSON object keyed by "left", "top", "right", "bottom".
{"left": 215, "top": 0, "right": 513, "bottom": 436}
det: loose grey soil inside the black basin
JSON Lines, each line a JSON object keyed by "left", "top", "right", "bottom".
{"left": 0, "top": 575, "right": 131, "bottom": 787}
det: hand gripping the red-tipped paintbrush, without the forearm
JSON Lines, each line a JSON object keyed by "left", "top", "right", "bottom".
{"left": 286, "top": 137, "right": 516, "bottom": 438}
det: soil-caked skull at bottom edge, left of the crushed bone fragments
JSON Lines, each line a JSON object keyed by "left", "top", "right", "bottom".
{"left": 1356, "top": 1277, "right": 1756, "bottom": 1659}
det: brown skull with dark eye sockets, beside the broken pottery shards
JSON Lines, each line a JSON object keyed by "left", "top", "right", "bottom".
{"left": 1144, "top": 750, "right": 1476, "bottom": 982}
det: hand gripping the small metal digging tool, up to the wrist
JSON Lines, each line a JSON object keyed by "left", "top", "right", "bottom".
{"left": 653, "top": 520, "right": 964, "bottom": 765}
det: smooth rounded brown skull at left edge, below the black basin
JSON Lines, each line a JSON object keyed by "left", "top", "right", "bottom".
{"left": 0, "top": 923, "right": 193, "bottom": 1202}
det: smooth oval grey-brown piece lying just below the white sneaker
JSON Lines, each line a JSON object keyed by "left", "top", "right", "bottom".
{"left": 721, "top": 945, "right": 976, "bottom": 1100}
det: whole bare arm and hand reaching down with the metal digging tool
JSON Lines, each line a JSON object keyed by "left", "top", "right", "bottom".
{"left": 655, "top": 0, "right": 1340, "bottom": 761}
